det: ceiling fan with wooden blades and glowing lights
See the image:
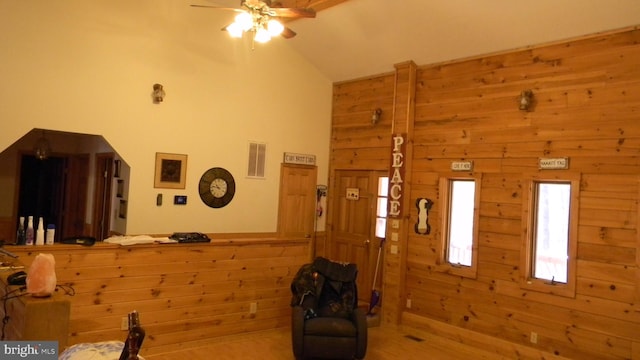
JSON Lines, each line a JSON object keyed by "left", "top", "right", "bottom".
{"left": 191, "top": 0, "right": 316, "bottom": 43}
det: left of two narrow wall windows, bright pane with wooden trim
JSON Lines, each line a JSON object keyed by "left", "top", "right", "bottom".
{"left": 440, "top": 177, "right": 480, "bottom": 277}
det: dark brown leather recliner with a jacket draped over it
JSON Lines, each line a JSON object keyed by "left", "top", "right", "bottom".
{"left": 291, "top": 257, "right": 367, "bottom": 359}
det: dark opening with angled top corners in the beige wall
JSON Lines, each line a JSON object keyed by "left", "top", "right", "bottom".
{"left": 0, "top": 129, "right": 131, "bottom": 244}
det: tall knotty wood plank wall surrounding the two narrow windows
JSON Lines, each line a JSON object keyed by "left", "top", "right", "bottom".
{"left": 332, "top": 28, "right": 640, "bottom": 359}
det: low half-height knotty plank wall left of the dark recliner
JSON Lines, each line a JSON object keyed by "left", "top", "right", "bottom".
{"left": 11, "top": 239, "right": 310, "bottom": 356}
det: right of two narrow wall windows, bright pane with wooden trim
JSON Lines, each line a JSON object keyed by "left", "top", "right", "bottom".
{"left": 522, "top": 178, "right": 580, "bottom": 296}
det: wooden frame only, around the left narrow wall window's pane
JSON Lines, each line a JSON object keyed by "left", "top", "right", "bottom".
{"left": 438, "top": 173, "right": 482, "bottom": 279}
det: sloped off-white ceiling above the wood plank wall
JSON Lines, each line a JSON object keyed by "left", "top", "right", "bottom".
{"left": 205, "top": 0, "right": 640, "bottom": 81}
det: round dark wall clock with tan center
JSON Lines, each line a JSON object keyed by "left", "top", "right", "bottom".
{"left": 199, "top": 167, "right": 236, "bottom": 208}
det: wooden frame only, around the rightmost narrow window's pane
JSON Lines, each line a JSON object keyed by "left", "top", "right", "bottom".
{"left": 520, "top": 173, "right": 581, "bottom": 298}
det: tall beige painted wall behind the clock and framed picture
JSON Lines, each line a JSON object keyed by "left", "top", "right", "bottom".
{"left": 0, "top": 0, "right": 332, "bottom": 234}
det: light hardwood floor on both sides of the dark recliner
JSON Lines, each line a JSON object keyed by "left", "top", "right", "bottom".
{"left": 141, "top": 327, "right": 502, "bottom": 360}
